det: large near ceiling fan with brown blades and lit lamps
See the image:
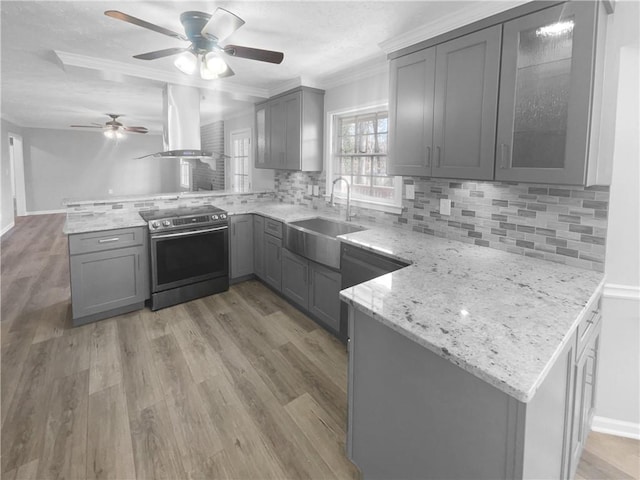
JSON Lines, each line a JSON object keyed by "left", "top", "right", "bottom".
{"left": 104, "top": 8, "right": 284, "bottom": 80}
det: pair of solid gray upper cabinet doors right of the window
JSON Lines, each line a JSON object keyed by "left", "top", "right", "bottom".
{"left": 389, "top": 25, "right": 501, "bottom": 180}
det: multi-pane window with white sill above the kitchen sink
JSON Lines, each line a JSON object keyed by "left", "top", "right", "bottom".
{"left": 327, "top": 107, "right": 402, "bottom": 211}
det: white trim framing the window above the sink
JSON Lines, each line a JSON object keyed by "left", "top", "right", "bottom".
{"left": 324, "top": 102, "right": 402, "bottom": 214}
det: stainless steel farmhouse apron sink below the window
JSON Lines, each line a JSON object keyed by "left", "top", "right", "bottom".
{"left": 284, "top": 217, "right": 366, "bottom": 270}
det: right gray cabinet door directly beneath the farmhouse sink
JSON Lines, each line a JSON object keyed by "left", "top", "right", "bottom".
{"left": 309, "top": 262, "right": 342, "bottom": 333}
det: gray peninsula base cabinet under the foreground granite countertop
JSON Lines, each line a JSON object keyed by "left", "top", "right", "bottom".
{"left": 347, "top": 292, "right": 599, "bottom": 480}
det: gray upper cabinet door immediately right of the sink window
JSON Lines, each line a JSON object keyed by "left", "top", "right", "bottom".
{"left": 388, "top": 48, "right": 436, "bottom": 176}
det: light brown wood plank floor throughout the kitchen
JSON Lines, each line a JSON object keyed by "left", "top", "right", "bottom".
{"left": 0, "top": 215, "right": 639, "bottom": 479}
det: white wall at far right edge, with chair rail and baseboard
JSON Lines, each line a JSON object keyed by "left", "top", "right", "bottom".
{"left": 594, "top": 1, "right": 640, "bottom": 438}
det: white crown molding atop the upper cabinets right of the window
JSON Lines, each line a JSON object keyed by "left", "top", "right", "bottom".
{"left": 378, "top": 0, "right": 529, "bottom": 54}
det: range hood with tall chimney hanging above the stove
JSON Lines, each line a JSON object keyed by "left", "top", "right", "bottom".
{"left": 141, "top": 84, "right": 226, "bottom": 164}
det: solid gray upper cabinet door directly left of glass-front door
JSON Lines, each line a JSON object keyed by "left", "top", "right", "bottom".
{"left": 431, "top": 25, "right": 502, "bottom": 180}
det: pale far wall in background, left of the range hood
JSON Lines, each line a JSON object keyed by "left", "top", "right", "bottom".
{"left": 22, "top": 128, "right": 178, "bottom": 213}
